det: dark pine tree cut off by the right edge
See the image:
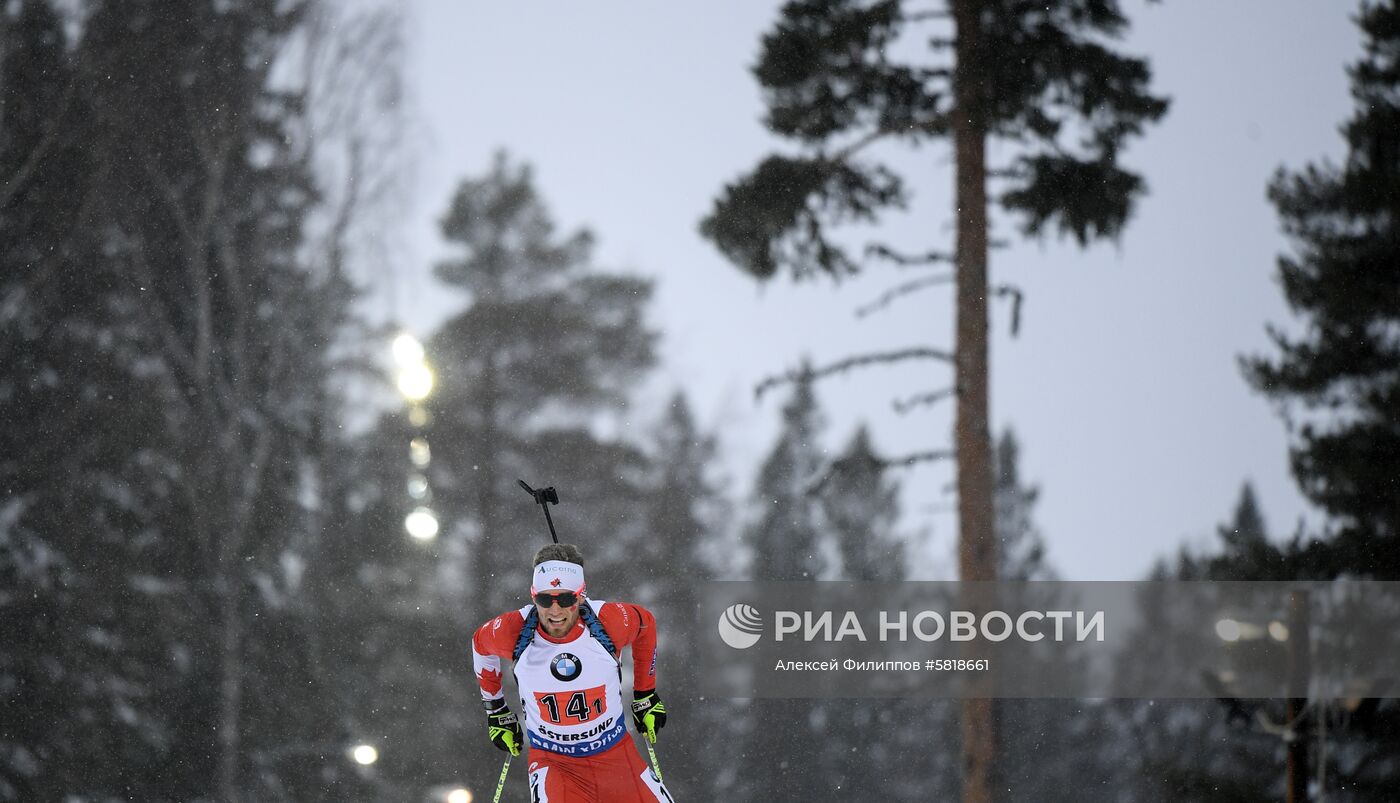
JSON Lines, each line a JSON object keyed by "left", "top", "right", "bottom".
{"left": 1182, "top": 6, "right": 1400, "bottom": 783}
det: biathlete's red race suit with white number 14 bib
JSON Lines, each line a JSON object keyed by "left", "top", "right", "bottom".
{"left": 472, "top": 599, "right": 672, "bottom": 803}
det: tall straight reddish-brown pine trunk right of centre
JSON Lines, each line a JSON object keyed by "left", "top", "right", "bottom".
{"left": 953, "top": 0, "right": 997, "bottom": 803}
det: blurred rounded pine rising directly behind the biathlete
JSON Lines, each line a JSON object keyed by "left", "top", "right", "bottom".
{"left": 427, "top": 154, "right": 655, "bottom": 618}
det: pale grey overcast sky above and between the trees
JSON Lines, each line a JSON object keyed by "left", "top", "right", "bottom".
{"left": 379, "top": 0, "right": 1359, "bottom": 579}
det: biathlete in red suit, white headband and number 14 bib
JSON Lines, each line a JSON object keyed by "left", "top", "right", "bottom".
{"left": 472, "top": 544, "right": 673, "bottom": 803}
